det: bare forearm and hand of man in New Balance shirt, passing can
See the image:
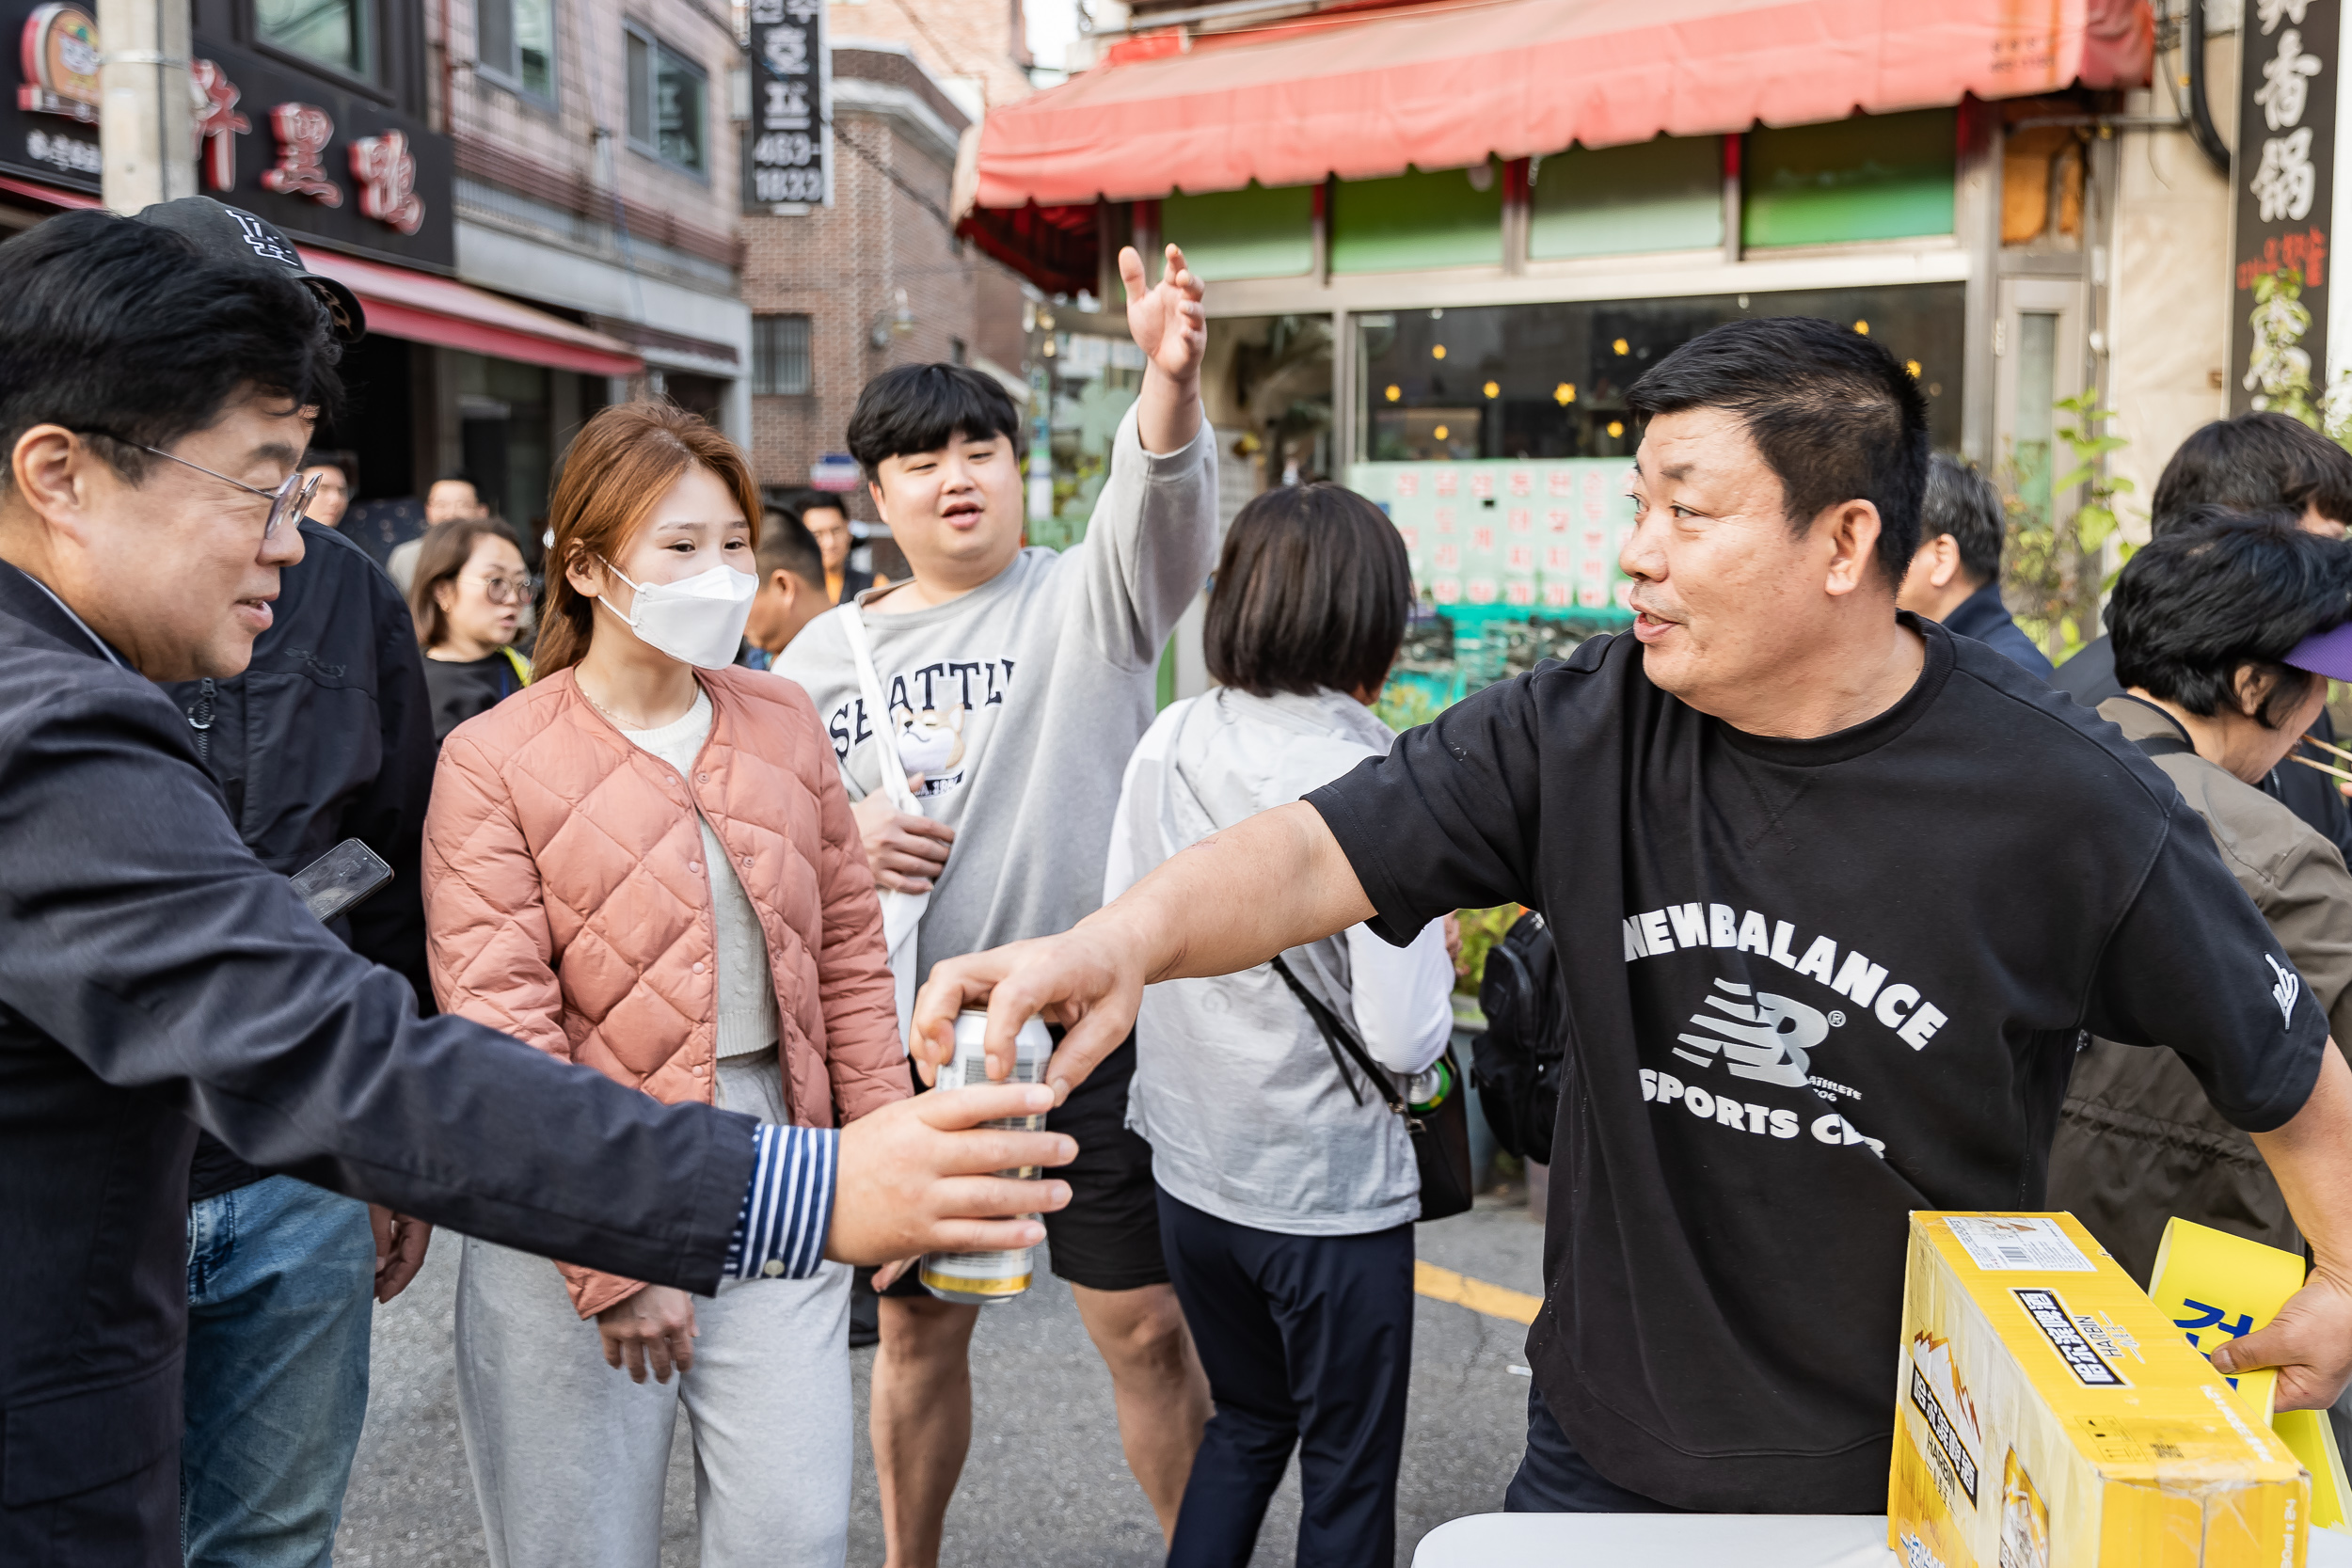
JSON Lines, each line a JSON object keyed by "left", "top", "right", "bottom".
{"left": 911, "top": 801, "right": 1374, "bottom": 1098}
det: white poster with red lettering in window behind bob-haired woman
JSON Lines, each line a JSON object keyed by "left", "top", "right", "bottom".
{"left": 1348, "top": 458, "right": 1632, "bottom": 621}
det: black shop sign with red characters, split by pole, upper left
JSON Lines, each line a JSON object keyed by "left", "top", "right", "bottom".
{"left": 0, "top": 0, "right": 456, "bottom": 273}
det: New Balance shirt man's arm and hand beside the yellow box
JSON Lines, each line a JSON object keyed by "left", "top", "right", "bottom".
{"left": 2214, "top": 1046, "right": 2352, "bottom": 1411}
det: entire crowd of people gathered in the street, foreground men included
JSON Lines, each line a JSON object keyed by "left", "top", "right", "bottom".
{"left": 13, "top": 199, "right": 2352, "bottom": 1568}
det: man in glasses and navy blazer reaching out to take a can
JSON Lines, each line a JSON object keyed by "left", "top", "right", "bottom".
{"left": 0, "top": 204, "right": 1073, "bottom": 1568}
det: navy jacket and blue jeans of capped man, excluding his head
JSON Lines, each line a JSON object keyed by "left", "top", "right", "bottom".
{"left": 165, "top": 493, "right": 436, "bottom": 1568}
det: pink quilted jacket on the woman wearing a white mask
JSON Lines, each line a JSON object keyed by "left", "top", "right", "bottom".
{"left": 423, "top": 670, "right": 908, "bottom": 1317}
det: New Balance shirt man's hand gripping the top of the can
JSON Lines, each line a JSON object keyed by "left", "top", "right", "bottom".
{"left": 908, "top": 922, "right": 1146, "bottom": 1102}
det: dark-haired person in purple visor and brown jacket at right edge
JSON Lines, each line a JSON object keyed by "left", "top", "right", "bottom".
{"left": 2046, "top": 505, "right": 2352, "bottom": 1279}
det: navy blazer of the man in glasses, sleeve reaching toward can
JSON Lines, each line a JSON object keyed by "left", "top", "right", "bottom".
{"left": 0, "top": 564, "right": 755, "bottom": 1568}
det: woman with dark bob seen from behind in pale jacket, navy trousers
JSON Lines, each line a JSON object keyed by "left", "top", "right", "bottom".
{"left": 1104, "top": 484, "right": 1463, "bottom": 1568}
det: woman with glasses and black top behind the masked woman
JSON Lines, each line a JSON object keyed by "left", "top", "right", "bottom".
{"left": 409, "top": 517, "right": 532, "bottom": 743}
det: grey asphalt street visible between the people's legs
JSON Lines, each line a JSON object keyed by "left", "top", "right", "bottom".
{"left": 337, "top": 1187, "right": 1543, "bottom": 1568}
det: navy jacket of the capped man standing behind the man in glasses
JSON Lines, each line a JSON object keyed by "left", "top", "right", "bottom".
{"left": 165, "top": 519, "right": 436, "bottom": 1199}
